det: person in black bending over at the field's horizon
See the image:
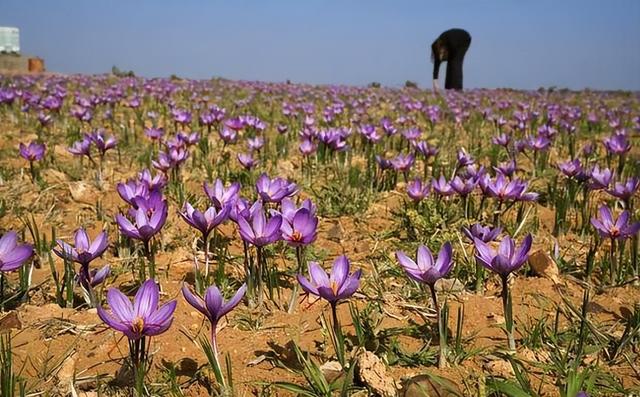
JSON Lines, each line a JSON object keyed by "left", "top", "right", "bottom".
{"left": 431, "top": 29, "right": 471, "bottom": 90}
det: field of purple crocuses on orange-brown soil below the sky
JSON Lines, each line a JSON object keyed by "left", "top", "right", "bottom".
{"left": 0, "top": 75, "right": 640, "bottom": 397}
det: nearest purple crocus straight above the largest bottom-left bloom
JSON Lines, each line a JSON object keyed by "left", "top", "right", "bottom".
{"left": 116, "top": 200, "right": 168, "bottom": 243}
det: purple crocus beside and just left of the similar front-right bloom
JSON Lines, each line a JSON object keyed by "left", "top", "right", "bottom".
{"left": 396, "top": 242, "right": 453, "bottom": 286}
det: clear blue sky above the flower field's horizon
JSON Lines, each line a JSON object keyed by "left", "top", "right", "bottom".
{"left": 0, "top": 0, "right": 640, "bottom": 90}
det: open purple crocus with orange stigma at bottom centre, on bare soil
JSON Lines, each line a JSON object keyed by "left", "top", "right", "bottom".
{"left": 297, "top": 255, "right": 362, "bottom": 305}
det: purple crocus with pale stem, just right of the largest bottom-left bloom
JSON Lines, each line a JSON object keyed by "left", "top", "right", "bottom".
{"left": 182, "top": 284, "right": 247, "bottom": 356}
